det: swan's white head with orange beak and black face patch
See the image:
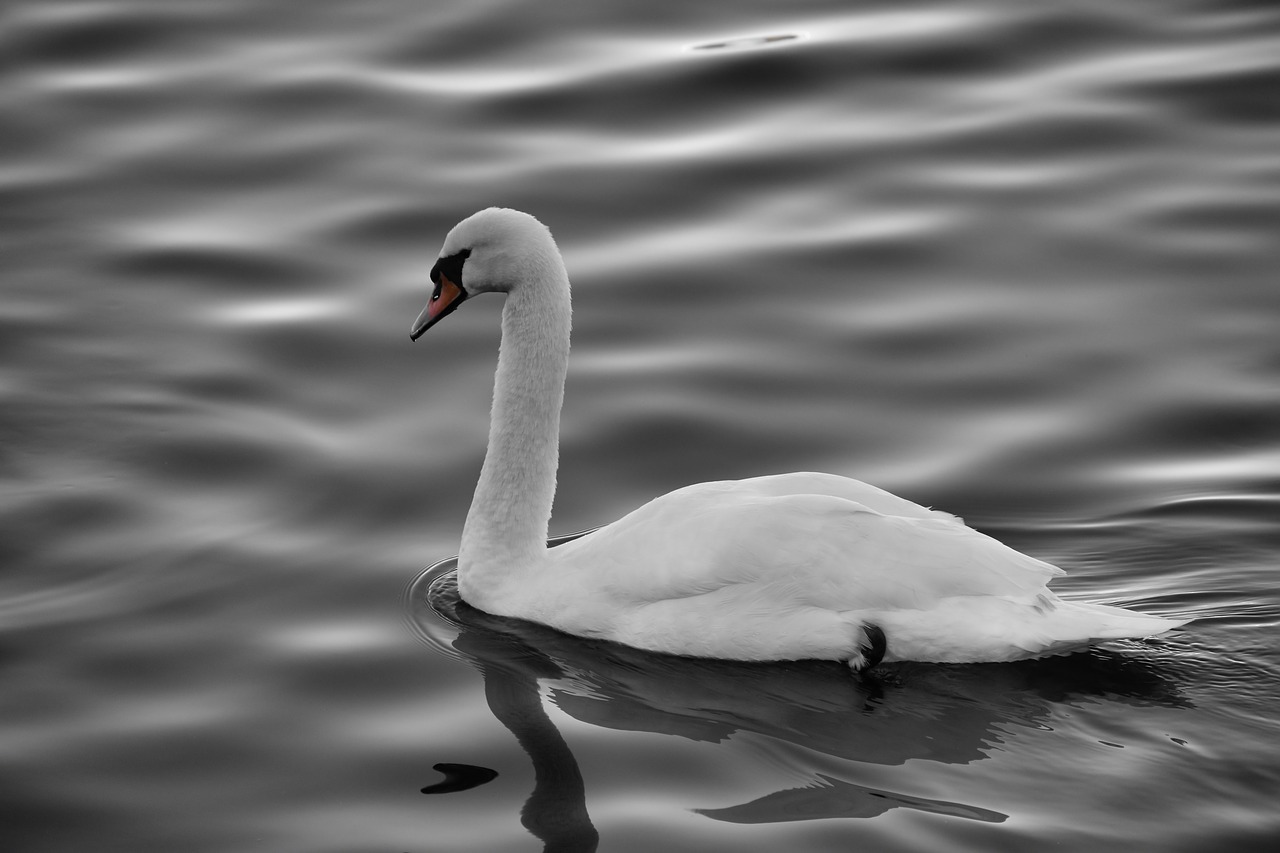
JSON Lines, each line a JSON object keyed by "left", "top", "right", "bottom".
{"left": 410, "top": 207, "right": 559, "bottom": 341}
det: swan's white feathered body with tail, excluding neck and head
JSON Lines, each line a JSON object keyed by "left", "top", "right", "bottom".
{"left": 539, "top": 475, "right": 1176, "bottom": 661}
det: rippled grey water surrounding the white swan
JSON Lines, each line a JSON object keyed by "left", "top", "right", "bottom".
{"left": 0, "top": 0, "right": 1280, "bottom": 853}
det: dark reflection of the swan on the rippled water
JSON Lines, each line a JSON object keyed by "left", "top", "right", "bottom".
{"left": 410, "top": 539, "right": 1183, "bottom": 850}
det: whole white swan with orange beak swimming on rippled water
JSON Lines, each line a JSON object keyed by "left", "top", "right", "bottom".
{"left": 410, "top": 207, "right": 1189, "bottom": 671}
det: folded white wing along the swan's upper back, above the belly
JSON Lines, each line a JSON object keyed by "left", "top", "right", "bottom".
{"left": 557, "top": 475, "right": 1061, "bottom": 610}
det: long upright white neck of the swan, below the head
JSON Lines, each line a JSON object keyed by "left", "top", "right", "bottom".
{"left": 458, "top": 255, "right": 571, "bottom": 596}
